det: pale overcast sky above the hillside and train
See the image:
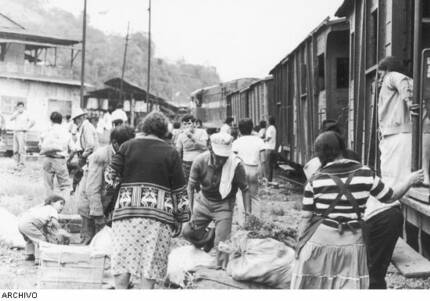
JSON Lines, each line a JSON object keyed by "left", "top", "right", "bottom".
{"left": 45, "top": 0, "right": 343, "bottom": 81}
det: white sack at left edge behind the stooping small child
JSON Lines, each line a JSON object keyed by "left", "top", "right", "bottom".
{"left": 0, "top": 208, "right": 25, "bottom": 249}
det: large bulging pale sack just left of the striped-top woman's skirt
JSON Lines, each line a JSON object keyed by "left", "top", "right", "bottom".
{"left": 226, "top": 233, "right": 294, "bottom": 288}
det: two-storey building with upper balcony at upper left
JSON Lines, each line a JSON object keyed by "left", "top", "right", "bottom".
{"left": 0, "top": 14, "right": 84, "bottom": 151}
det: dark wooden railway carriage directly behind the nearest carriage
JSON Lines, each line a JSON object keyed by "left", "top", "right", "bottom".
{"left": 268, "top": 18, "right": 349, "bottom": 165}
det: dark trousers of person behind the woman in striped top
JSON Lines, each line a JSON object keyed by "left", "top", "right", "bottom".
{"left": 365, "top": 206, "right": 403, "bottom": 289}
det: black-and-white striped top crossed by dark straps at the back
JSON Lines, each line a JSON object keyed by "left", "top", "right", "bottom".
{"left": 302, "top": 159, "right": 393, "bottom": 219}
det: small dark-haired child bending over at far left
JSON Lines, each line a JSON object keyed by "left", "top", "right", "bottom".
{"left": 18, "top": 195, "right": 70, "bottom": 261}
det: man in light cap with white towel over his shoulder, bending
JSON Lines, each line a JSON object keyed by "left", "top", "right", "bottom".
{"left": 183, "top": 133, "right": 251, "bottom": 268}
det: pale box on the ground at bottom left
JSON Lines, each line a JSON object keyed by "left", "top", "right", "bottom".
{"left": 39, "top": 243, "right": 106, "bottom": 289}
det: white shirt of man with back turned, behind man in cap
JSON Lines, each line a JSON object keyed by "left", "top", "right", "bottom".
{"left": 232, "top": 135, "right": 265, "bottom": 166}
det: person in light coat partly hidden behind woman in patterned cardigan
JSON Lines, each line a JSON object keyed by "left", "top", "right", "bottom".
{"left": 78, "top": 125, "right": 134, "bottom": 245}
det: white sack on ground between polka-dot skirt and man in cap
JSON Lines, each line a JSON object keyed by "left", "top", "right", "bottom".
{"left": 167, "top": 245, "right": 215, "bottom": 287}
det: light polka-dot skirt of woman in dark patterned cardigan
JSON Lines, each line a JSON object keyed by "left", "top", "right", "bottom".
{"left": 111, "top": 218, "right": 171, "bottom": 281}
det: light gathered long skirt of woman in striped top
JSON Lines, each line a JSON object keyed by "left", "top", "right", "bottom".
{"left": 291, "top": 225, "right": 369, "bottom": 289}
